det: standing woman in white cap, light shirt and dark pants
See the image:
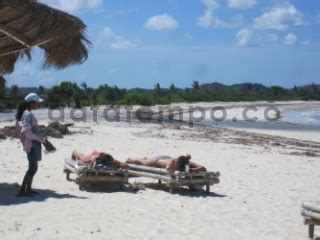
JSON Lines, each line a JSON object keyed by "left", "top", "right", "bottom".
{"left": 16, "top": 93, "right": 47, "bottom": 197}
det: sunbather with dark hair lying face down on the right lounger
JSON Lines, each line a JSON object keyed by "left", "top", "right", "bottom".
{"left": 126, "top": 155, "right": 207, "bottom": 173}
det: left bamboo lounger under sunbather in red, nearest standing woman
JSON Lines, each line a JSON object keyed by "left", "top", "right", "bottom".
{"left": 64, "top": 159, "right": 128, "bottom": 190}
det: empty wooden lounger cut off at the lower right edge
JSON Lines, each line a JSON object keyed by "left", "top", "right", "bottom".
{"left": 301, "top": 201, "right": 320, "bottom": 239}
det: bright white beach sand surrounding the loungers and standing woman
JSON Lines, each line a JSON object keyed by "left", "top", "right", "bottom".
{"left": 0, "top": 101, "right": 320, "bottom": 240}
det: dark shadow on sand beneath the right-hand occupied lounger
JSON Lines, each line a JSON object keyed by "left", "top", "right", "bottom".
{"left": 144, "top": 183, "right": 227, "bottom": 198}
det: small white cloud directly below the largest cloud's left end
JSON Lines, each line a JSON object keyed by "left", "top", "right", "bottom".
{"left": 236, "top": 28, "right": 279, "bottom": 47}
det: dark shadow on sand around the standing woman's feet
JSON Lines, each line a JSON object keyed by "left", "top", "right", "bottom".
{"left": 0, "top": 183, "right": 86, "bottom": 206}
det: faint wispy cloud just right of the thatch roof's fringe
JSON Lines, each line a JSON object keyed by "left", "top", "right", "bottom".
{"left": 103, "top": 26, "right": 136, "bottom": 49}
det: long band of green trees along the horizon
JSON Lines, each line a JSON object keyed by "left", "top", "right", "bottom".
{"left": 0, "top": 80, "right": 320, "bottom": 109}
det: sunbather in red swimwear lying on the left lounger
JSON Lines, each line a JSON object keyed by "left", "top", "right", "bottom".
{"left": 72, "top": 150, "right": 128, "bottom": 169}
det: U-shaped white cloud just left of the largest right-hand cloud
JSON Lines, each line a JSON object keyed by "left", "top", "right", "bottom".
{"left": 198, "top": 8, "right": 243, "bottom": 28}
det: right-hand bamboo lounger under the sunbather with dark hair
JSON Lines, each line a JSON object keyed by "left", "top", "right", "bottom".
{"left": 128, "top": 164, "right": 220, "bottom": 193}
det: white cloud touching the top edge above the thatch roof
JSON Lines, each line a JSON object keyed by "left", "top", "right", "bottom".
{"left": 40, "top": 0, "right": 103, "bottom": 12}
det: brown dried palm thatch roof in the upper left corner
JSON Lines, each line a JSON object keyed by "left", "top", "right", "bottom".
{"left": 0, "top": 0, "right": 90, "bottom": 74}
